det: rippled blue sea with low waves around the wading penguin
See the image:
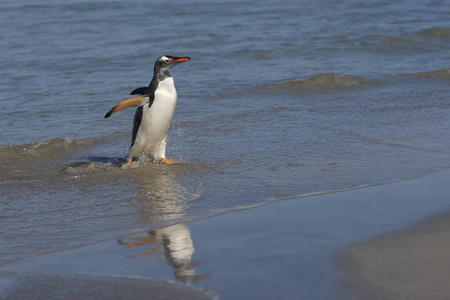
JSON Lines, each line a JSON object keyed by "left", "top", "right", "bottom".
{"left": 0, "top": 0, "right": 450, "bottom": 265}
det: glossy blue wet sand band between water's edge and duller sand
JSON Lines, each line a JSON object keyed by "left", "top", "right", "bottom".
{"left": 0, "top": 169, "right": 450, "bottom": 299}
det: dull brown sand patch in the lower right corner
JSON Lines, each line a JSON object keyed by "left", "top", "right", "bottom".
{"left": 336, "top": 212, "right": 450, "bottom": 300}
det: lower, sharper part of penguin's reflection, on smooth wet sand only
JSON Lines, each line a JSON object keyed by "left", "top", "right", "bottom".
{"left": 118, "top": 224, "right": 211, "bottom": 284}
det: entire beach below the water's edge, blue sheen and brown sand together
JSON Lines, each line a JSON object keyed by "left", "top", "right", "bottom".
{"left": 0, "top": 170, "right": 450, "bottom": 300}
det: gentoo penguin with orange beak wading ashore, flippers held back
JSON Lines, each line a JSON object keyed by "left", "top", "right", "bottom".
{"left": 105, "top": 55, "right": 190, "bottom": 165}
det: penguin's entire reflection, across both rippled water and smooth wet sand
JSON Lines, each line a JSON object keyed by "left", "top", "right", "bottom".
{"left": 118, "top": 158, "right": 210, "bottom": 283}
